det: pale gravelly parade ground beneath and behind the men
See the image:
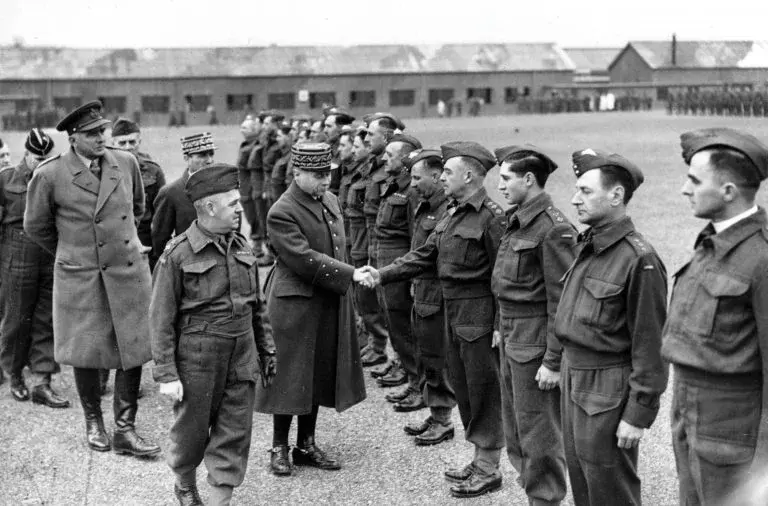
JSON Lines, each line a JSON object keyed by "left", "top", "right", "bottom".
{"left": 0, "top": 112, "right": 768, "bottom": 506}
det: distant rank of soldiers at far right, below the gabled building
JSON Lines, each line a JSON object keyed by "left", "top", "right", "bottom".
{"left": 667, "top": 89, "right": 768, "bottom": 116}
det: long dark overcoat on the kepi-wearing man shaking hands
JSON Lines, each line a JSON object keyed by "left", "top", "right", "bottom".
{"left": 256, "top": 182, "right": 366, "bottom": 415}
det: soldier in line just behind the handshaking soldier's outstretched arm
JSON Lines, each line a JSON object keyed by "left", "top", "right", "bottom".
{"left": 403, "top": 149, "right": 456, "bottom": 446}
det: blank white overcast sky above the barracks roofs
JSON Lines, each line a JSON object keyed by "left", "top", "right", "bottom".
{"left": 6, "top": 0, "right": 768, "bottom": 47}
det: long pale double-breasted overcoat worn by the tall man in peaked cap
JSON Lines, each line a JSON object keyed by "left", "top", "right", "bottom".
{"left": 24, "top": 145, "right": 152, "bottom": 369}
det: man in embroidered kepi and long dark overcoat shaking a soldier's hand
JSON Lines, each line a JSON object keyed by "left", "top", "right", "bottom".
{"left": 256, "top": 143, "right": 366, "bottom": 475}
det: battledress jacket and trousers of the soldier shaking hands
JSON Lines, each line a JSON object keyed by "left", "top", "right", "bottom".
{"left": 380, "top": 188, "right": 505, "bottom": 450}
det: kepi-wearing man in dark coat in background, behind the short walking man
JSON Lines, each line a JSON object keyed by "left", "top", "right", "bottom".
{"left": 152, "top": 132, "right": 216, "bottom": 254}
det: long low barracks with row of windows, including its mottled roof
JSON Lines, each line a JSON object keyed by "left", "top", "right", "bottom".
{"left": 0, "top": 43, "right": 574, "bottom": 125}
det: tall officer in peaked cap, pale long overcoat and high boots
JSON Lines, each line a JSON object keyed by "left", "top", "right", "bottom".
{"left": 24, "top": 101, "right": 160, "bottom": 456}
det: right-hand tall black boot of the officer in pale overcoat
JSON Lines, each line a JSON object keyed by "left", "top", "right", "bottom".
{"left": 112, "top": 367, "right": 160, "bottom": 457}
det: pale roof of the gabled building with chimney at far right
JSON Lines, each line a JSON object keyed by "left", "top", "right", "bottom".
{"left": 614, "top": 40, "right": 768, "bottom": 69}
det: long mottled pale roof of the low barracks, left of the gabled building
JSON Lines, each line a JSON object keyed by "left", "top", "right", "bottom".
{"left": 0, "top": 43, "right": 574, "bottom": 79}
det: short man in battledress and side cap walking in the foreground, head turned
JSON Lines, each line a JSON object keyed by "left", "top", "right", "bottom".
{"left": 149, "top": 164, "right": 277, "bottom": 506}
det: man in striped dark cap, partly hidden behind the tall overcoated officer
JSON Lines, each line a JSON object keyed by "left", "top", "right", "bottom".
{"left": 0, "top": 128, "right": 69, "bottom": 408}
